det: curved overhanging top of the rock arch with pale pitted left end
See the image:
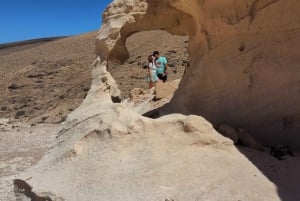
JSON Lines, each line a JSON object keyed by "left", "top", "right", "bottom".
{"left": 96, "top": 0, "right": 193, "bottom": 62}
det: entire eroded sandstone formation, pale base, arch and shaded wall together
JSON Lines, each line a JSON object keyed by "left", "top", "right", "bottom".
{"left": 14, "top": 0, "right": 300, "bottom": 201}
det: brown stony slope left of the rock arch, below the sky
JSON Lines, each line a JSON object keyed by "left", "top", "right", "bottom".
{"left": 0, "top": 32, "right": 96, "bottom": 123}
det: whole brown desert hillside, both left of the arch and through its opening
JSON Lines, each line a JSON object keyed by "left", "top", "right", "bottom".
{"left": 0, "top": 31, "right": 188, "bottom": 123}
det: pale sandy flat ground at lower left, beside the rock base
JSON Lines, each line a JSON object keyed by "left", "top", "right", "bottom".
{"left": 0, "top": 122, "right": 61, "bottom": 201}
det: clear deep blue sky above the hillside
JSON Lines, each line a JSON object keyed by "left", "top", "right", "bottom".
{"left": 0, "top": 0, "right": 112, "bottom": 44}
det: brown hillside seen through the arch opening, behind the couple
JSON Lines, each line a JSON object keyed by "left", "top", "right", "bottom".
{"left": 108, "top": 30, "right": 189, "bottom": 102}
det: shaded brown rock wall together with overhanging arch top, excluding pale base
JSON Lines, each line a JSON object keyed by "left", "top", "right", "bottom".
{"left": 97, "top": 0, "right": 300, "bottom": 146}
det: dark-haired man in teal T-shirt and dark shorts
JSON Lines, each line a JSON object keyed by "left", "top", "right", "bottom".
{"left": 153, "top": 51, "right": 169, "bottom": 82}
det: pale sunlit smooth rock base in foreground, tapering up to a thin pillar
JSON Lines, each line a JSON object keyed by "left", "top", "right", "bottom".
{"left": 14, "top": 60, "right": 279, "bottom": 201}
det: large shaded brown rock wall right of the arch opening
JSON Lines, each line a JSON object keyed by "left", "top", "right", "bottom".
{"left": 166, "top": 0, "right": 300, "bottom": 148}
